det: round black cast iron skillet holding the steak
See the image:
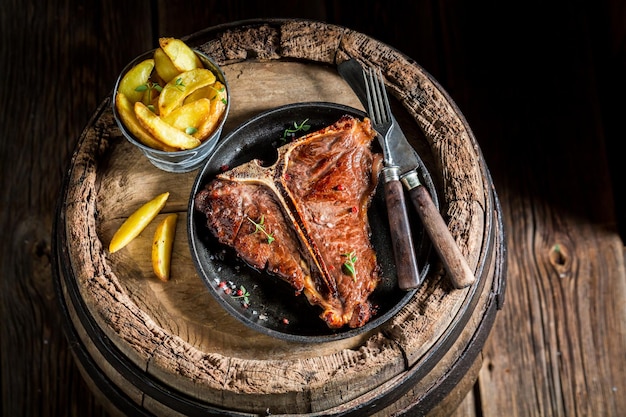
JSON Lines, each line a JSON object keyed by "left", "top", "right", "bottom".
{"left": 187, "top": 102, "right": 438, "bottom": 342}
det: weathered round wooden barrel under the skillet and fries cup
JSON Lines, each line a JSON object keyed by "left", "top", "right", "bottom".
{"left": 53, "top": 19, "right": 506, "bottom": 416}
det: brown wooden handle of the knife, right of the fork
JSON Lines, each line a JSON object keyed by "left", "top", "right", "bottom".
{"left": 409, "top": 184, "right": 476, "bottom": 289}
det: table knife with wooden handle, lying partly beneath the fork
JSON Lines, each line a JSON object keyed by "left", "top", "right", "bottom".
{"left": 337, "top": 59, "right": 476, "bottom": 289}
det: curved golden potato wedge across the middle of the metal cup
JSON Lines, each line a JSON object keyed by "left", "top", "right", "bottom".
{"left": 159, "top": 68, "right": 216, "bottom": 117}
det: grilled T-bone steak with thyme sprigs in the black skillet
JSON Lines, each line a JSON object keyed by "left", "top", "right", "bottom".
{"left": 194, "top": 116, "right": 382, "bottom": 328}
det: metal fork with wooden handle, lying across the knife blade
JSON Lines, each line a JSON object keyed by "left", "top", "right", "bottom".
{"left": 363, "top": 68, "right": 421, "bottom": 290}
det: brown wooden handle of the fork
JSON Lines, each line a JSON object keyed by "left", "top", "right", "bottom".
{"left": 385, "top": 179, "right": 420, "bottom": 291}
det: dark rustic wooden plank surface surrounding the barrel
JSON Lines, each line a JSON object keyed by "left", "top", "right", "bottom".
{"left": 0, "top": 0, "right": 626, "bottom": 416}
